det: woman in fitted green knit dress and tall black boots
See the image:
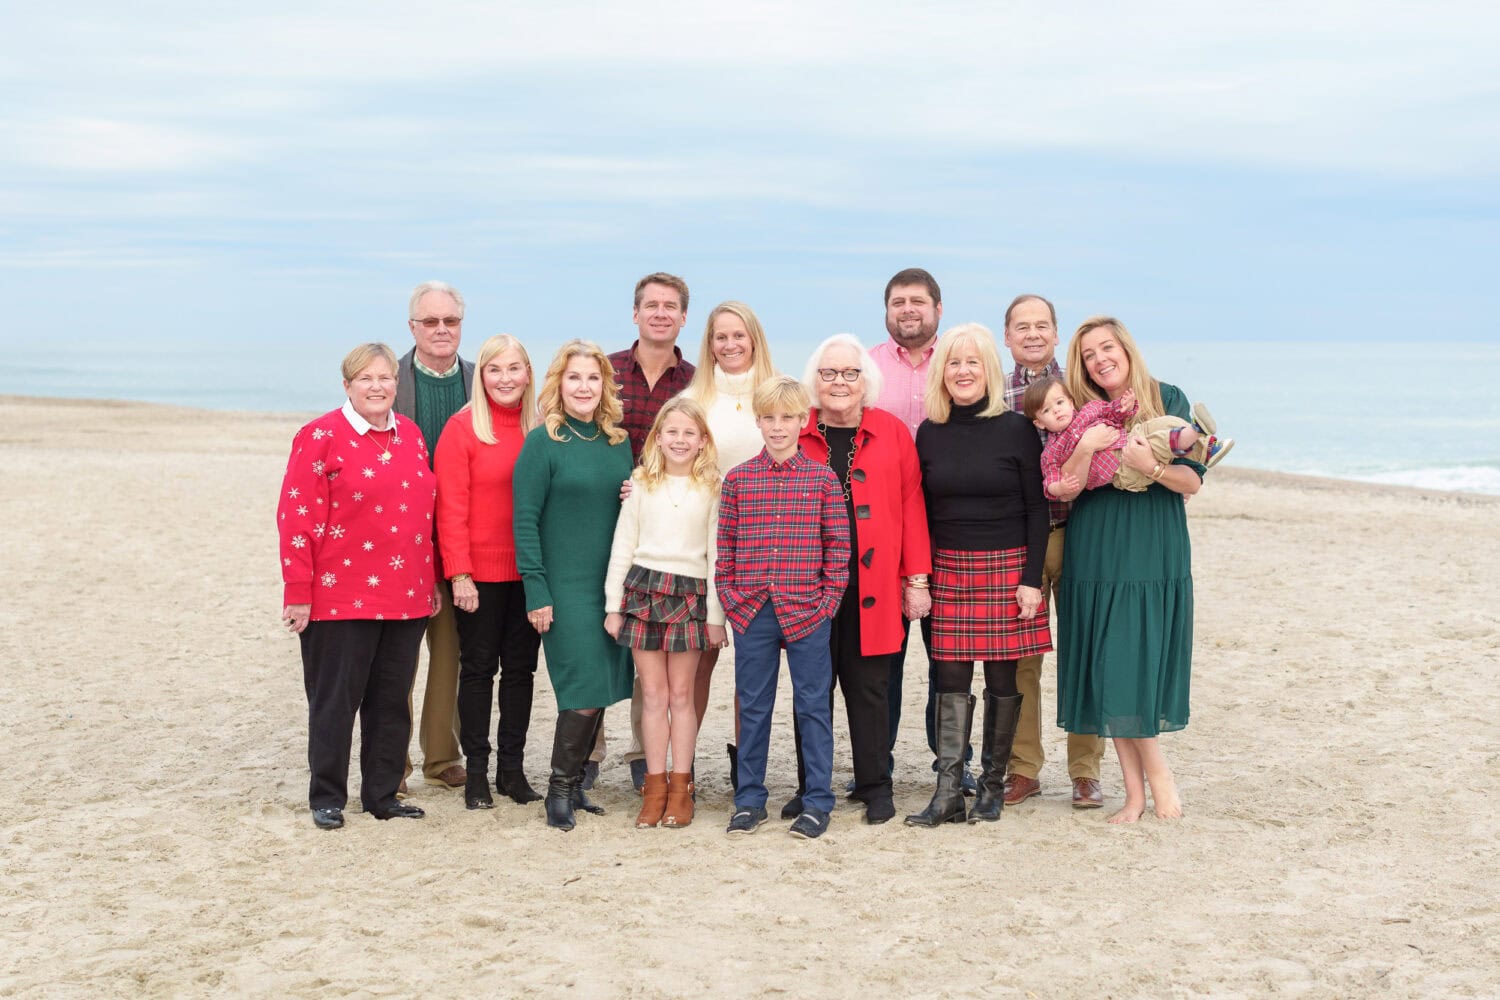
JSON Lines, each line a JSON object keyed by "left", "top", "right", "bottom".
{"left": 513, "top": 340, "right": 633, "bottom": 831}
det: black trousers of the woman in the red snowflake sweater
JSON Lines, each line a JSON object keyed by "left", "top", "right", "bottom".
{"left": 302, "top": 618, "right": 428, "bottom": 813}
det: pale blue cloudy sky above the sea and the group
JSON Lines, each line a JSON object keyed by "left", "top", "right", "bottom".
{"left": 0, "top": 0, "right": 1500, "bottom": 401}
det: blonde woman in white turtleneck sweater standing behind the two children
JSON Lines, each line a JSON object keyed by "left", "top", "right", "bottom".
{"left": 683, "top": 301, "right": 776, "bottom": 786}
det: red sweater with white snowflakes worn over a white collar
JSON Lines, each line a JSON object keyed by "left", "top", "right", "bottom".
{"left": 276, "top": 409, "right": 437, "bottom": 621}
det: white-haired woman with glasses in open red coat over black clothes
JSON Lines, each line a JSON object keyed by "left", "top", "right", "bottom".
{"left": 782, "top": 333, "right": 932, "bottom": 823}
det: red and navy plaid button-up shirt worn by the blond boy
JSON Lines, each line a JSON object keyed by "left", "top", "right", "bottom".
{"left": 714, "top": 448, "right": 849, "bottom": 642}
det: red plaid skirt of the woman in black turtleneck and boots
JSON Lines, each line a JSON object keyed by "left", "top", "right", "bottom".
{"left": 932, "top": 547, "right": 1052, "bottom": 663}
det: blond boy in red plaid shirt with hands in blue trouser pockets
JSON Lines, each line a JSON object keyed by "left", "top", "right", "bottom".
{"left": 714, "top": 375, "right": 849, "bottom": 840}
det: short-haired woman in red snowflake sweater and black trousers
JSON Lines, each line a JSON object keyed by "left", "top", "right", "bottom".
{"left": 276, "top": 343, "right": 437, "bottom": 829}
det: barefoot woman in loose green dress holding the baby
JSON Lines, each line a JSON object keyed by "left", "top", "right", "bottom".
{"left": 1058, "top": 316, "right": 1205, "bottom": 823}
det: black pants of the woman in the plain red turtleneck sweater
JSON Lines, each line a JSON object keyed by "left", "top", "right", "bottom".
{"left": 455, "top": 580, "right": 542, "bottom": 769}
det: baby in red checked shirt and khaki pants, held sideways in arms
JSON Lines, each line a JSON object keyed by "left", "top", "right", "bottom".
{"left": 1022, "top": 378, "right": 1235, "bottom": 496}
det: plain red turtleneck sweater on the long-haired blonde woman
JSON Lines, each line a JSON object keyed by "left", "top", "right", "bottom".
{"left": 435, "top": 394, "right": 525, "bottom": 583}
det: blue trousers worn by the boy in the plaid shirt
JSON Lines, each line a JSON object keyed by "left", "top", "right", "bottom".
{"left": 735, "top": 601, "right": 834, "bottom": 813}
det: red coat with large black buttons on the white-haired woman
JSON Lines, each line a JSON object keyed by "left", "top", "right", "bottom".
{"left": 798, "top": 406, "right": 933, "bottom": 657}
